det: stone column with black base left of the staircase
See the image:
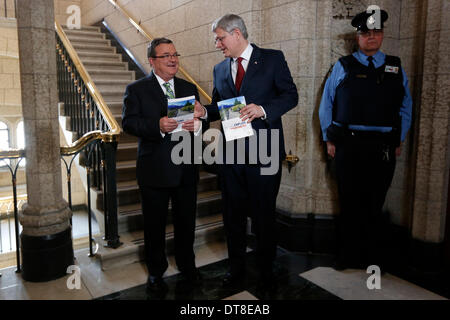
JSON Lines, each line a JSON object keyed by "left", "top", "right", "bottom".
{"left": 17, "top": 0, "right": 73, "bottom": 281}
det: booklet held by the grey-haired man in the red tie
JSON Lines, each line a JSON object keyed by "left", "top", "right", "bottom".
{"left": 217, "top": 96, "right": 253, "bottom": 141}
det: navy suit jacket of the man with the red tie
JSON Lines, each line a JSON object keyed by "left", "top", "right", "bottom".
{"left": 206, "top": 44, "right": 298, "bottom": 161}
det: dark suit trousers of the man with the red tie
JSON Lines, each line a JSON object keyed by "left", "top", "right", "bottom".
{"left": 219, "top": 164, "right": 281, "bottom": 273}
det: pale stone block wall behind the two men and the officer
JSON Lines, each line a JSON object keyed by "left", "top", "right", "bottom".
{"left": 81, "top": 0, "right": 449, "bottom": 241}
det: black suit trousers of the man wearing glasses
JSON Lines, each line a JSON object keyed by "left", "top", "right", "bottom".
{"left": 140, "top": 184, "right": 197, "bottom": 277}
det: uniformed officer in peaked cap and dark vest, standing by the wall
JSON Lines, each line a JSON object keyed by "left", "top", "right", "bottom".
{"left": 319, "top": 9, "right": 412, "bottom": 272}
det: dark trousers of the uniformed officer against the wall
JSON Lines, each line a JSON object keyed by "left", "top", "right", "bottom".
{"left": 335, "top": 134, "right": 396, "bottom": 268}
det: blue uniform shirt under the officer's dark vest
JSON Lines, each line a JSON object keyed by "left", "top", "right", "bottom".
{"left": 319, "top": 50, "right": 412, "bottom": 141}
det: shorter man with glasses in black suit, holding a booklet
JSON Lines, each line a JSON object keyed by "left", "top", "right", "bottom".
{"left": 122, "top": 38, "right": 199, "bottom": 291}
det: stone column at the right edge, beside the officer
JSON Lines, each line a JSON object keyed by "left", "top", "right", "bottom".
{"left": 412, "top": 0, "right": 450, "bottom": 243}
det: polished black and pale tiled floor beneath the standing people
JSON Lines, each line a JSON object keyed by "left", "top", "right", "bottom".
{"left": 0, "top": 242, "right": 448, "bottom": 301}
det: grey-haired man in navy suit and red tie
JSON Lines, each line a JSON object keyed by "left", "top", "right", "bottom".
{"left": 197, "top": 14, "right": 298, "bottom": 284}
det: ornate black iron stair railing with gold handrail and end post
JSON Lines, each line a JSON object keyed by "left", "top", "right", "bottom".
{"left": 55, "top": 22, "right": 121, "bottom": 248}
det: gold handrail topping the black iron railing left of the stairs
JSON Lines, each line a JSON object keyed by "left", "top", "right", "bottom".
{"left": 55, "top": 21, "right": 120, "bottom": 142}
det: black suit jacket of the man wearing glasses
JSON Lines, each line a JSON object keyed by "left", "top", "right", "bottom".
{"left": 122, "top": 72, "right": 199, "bottom": 188}
